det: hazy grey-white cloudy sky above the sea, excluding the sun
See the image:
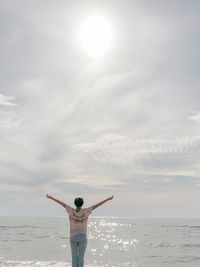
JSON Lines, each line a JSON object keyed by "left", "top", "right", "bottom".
{"left": 0, "top": 0, "right": 200, "bottom": 218}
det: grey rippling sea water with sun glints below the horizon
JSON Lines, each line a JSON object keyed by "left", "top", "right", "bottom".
{"left": 0, "top": 217, "right": 200, "bottom": 267}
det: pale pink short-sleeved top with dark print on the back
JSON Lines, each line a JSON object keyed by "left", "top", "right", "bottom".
{"left": 66, "top": 205, "right": 92, "bottom": 236}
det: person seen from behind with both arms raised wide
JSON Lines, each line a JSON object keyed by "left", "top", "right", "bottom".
{"left": 47, "top": 195, "right": 113, "bottom": 267}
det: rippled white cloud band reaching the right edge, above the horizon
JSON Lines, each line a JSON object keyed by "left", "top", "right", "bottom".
{"left": 75, "top": 134, "right": 200, "bottom": 173}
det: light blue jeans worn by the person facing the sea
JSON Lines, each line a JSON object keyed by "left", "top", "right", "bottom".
{"left": 70, "top": 234, "right": 87, "bottom": 267}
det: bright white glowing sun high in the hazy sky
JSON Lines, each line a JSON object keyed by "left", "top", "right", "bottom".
{"left": 80, "top": 15, "right": 113, "bottom": 57}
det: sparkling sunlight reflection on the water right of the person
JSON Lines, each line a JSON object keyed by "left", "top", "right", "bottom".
{"left": 88, "top": 218, "right": 139, "bottom": 266}
